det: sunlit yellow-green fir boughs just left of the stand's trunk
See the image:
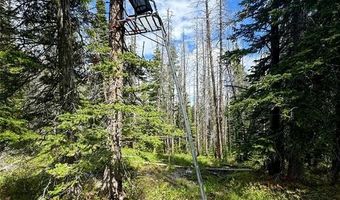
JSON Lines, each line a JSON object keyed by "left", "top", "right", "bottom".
{"left": 5, "top": 103, "right": 112, "bottom": 198}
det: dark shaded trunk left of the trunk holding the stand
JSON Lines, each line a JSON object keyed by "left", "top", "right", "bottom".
{"left": 57, "top": 0, "right": 76, "bottom": 112}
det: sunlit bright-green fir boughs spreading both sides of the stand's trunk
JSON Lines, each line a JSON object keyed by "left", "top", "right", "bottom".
{"left": 1, "top": 91, "right": 175, "bottom": 198}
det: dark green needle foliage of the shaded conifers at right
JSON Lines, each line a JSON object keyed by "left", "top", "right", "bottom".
{"left": 230, "top": 0, "right": 339, "bottom": 175}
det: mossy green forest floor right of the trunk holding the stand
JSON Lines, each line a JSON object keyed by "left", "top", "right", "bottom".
{"left": 123, "top": 149, "right": 340, "bottom": 200}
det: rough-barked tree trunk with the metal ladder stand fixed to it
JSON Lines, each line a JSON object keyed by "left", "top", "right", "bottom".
{"left": 105, "top": 0, "right": 124, "bottom": 200}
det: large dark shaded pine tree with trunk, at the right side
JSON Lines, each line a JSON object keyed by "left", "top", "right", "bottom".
{"left": 233, "top": 1, "right": 337, "bottom": 179}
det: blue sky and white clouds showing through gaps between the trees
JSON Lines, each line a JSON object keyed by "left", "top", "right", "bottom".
{"left": 93, "top": 0, "right": 257, "bottom": 102}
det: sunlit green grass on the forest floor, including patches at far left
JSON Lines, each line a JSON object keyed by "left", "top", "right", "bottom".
{"left": 0, "top": 149, "right": 340, "bottom": 200}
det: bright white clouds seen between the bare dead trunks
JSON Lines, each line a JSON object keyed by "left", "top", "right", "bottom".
{"left": 123, "top": 0, "right": 257, "bottom": 102}
